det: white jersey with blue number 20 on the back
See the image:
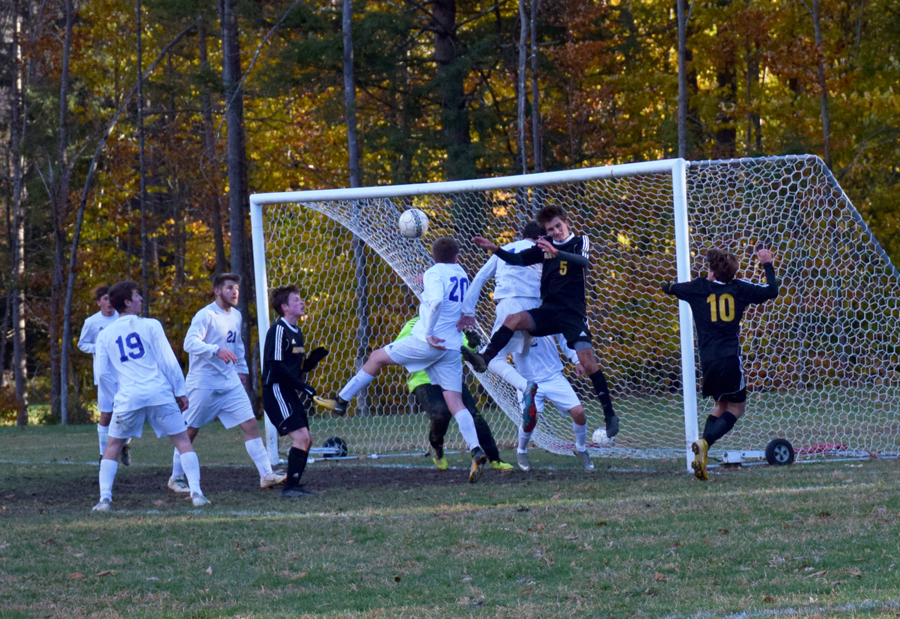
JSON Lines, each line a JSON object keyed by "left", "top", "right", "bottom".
{"left": 410, "top": 262, "right": 469, "bottom": 350}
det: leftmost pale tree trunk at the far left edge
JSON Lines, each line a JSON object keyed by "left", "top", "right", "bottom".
{"left": 10, "top": 2, "right": 28, "bottom": 426}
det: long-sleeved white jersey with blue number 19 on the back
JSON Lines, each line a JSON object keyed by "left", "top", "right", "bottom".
{"left": 94, "top": 315, "right": 187, "bottom": 412}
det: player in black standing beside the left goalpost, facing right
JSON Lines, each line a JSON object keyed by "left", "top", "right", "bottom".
{"left": 263, "top": 286, "right": 328, "bottom": 498}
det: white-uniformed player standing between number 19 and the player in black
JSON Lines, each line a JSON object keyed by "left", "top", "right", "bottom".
{"left": 168, "top": 273, "right": 287, "bottom": 492}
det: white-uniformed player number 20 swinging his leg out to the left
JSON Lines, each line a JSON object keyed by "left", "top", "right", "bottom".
{"left": 313, "top": 237, "right": 487, "bottom": 483}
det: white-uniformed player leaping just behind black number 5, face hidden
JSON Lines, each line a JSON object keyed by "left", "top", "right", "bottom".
{"left": 460, "top": 221, "right": 544, "bottom": 425}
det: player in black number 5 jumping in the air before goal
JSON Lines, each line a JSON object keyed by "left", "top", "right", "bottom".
{"left": 460, "top": 204, "right": 619, "bottom": 438}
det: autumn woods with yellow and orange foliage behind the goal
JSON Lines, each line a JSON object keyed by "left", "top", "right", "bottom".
{"left": 0, "top": 0, "right": 900, "bottom": 424}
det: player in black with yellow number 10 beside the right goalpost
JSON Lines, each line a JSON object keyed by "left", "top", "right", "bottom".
{"left": 662, "top": 249, "right": 778, "bottom": 479}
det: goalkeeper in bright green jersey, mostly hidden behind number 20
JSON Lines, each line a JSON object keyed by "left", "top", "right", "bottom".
{"left": 394, "top": 316, "right": 513, "bottom": 471}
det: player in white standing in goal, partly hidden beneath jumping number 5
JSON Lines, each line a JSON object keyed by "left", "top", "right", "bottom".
{"left": 513, "top": 334, "right": 594, "bottom": 471}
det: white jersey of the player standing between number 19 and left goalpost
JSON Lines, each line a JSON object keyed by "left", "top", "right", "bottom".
{"left": 184, "top": 302, "right": 250, "bottom": 389}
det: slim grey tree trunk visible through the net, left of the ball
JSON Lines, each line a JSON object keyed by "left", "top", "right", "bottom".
{"left": 341, "top": 0, "right": 369, "bottom": 415}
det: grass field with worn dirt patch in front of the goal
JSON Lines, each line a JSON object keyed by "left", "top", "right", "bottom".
{"left": 0, "top": 426, "right": 900, "bottom": 619}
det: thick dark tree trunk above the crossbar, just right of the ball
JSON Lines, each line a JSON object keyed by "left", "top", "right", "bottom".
{"left": 432, "top": 0, "right": 476, "bottom": 180}
